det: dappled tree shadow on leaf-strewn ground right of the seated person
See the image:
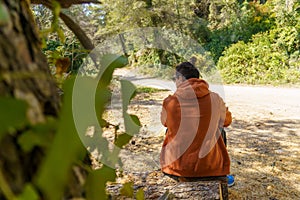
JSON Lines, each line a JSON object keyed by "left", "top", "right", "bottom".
{"left": 227, "top": 119, "right": 300, "bottom": 200}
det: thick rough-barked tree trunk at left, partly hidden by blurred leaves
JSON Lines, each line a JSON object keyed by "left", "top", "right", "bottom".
{"left": 0, "top": 0, "right": 60, "bottom": 199}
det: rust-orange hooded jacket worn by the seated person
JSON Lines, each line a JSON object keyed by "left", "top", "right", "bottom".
{"left": 160, "top": 78, "right": 232, "bottom": 177}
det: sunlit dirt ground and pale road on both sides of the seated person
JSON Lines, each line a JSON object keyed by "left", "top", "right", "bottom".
{"left": 105, "top": 69, "right": 300, "bottom": 200}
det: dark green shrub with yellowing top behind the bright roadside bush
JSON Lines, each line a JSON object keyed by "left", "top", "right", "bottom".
{"left": 204, "top": 2, "right": 275, "bottom": 62}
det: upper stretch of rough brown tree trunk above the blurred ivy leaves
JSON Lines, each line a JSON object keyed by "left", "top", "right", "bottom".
{"left": 0, "top": 0, "right": 59, "bottom": 118}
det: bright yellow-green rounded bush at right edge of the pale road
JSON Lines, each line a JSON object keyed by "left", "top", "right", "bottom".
{"left": 217, "top": 26, "right": 300, "bottom": 84}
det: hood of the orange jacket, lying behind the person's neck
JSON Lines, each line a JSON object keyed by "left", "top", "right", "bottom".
{"left": 175, "top": 78, "right": 209, "bottom": 99}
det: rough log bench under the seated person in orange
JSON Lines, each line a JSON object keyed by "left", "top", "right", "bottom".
{"left": 106, "top": 170, "right": 228, "bottom": 200}
